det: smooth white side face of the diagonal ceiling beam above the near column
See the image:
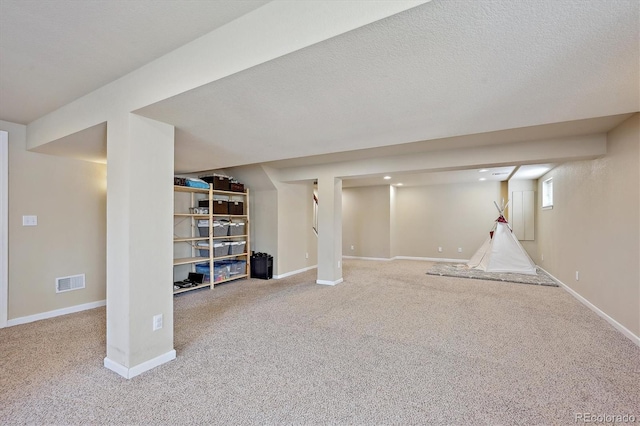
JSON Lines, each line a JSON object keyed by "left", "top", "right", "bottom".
{"left": 27, "top": 0, "right": 429, "bottom": 149}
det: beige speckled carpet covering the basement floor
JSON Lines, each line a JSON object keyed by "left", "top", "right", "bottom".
{"left": 0, "top": 260, "right": 640, "bottom": 425}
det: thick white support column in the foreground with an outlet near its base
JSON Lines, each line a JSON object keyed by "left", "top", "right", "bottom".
{"left": 104, "top": 114, "right": 176, "bottom": 378}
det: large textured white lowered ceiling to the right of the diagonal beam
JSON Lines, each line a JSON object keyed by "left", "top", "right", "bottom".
{"left": 138, "top": 0, "right": 640, "bottom": 171}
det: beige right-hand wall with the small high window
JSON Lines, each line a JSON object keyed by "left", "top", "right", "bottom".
{"left": 536, "top": 114, "right": 640, "bottom": 336}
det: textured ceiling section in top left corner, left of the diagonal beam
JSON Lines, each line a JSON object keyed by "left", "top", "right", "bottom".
{"left": 0, "top": 0, "right": 267, "bottom": 124}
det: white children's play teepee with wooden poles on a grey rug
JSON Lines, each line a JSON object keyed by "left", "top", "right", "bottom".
{"left": 467, "top": 200, "right": 537, "bottom": 275}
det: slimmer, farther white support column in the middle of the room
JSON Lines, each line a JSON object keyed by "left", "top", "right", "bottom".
{"left": 316, "top": 175, "right": 342, "bottom": 285}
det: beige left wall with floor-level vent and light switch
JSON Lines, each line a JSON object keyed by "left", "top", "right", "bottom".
{"left": 0, "top": 121, "right": 106, "bottom": 323}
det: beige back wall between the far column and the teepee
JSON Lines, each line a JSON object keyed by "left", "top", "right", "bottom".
{"left": 343, "top": 182, "right": 502, "bottom": 259}
